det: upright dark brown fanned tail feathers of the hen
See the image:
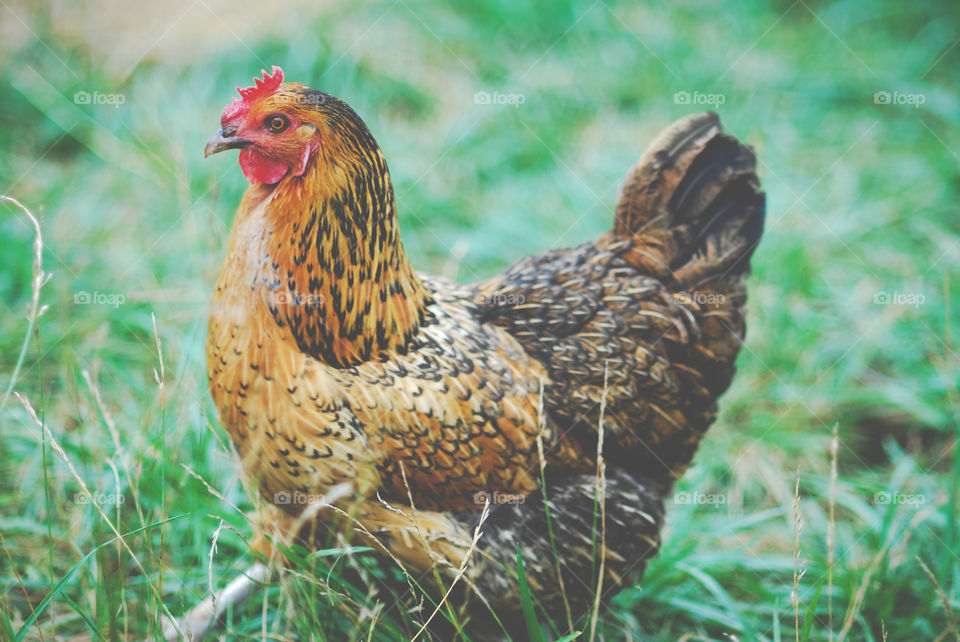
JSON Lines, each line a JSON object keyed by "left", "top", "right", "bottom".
{"left": 614, "top": 111, "right": 765, "bottom": 289}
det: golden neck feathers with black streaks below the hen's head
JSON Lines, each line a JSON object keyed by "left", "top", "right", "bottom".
{"left": 251, "top": 136, "right": 430, "bottom": 367}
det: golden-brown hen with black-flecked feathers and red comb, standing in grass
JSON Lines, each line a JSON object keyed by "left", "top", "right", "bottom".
{"left": 204, "top": 67, "right": 764, "bottom": 632}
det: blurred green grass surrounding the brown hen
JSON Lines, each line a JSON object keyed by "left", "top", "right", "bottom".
{"left": 0, "top": 0, "right": 960, "bottom": 641}
